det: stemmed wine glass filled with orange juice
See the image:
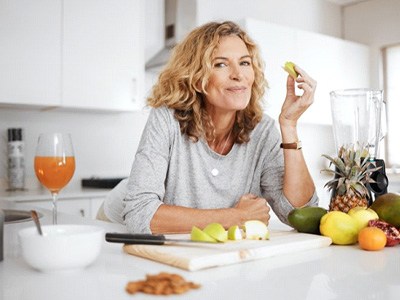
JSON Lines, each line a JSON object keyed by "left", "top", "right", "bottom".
{"left": 34, "top": 133, "right": 75, "bottom": 224}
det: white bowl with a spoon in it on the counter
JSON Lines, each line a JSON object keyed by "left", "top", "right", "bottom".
{"left": 18, "top": 225, "right": 104, "bottom": 272}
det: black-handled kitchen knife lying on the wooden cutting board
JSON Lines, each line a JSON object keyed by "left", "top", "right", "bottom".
{"left": 106, "top": 232, "right": 217, "bottom": 245}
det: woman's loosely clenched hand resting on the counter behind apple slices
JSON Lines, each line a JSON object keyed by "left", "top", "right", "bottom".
{"left": 235, "top": 194, "right": 270, "bottom": 224}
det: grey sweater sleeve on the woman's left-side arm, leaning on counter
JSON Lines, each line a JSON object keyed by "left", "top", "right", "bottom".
{"left": 123, "top": 109, "right": 171, "bottom": 233}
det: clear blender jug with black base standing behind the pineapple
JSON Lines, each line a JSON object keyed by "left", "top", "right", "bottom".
{"left": 330, "top": 89, "right": 389, "bottom": 205}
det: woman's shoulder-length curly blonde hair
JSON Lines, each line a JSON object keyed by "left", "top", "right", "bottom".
{"left": 147, "top": 21, "right": 267, "bottom": 144}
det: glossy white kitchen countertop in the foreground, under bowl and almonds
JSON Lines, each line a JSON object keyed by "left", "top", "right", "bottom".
{"left": 0, "top": 201, "right": 400, "bottom": 300}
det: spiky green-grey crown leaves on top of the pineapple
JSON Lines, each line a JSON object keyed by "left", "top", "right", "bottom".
{"left": 321, "top": 145, "right": 381, "bottom": 197}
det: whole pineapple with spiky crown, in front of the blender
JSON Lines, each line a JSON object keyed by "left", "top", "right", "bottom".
{"left": 322, "top": 146, "right": 380, "bottom": 213}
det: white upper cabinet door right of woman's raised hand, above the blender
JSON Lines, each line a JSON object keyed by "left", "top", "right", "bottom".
{"left": 296, "top": 30, "right": 369, "bottom": 124}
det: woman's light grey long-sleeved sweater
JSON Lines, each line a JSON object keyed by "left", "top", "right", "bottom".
{"left": 121, "top": 107, "right": 318, "bottom": 233}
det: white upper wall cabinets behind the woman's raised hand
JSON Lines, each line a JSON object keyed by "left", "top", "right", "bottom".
{"left": 243, "top": 19, "right": 370, "bottom": 124}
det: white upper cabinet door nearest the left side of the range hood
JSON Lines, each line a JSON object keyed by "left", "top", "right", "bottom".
{"left": 62, "top": 0, "right": 144, "bottom": 111}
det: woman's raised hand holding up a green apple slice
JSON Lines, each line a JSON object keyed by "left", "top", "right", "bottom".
{"left": 279, "top": 66, "right": 317, "bottom": 126}
